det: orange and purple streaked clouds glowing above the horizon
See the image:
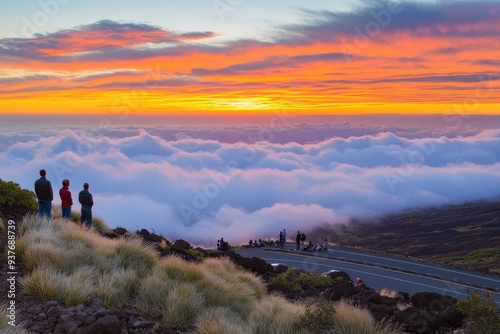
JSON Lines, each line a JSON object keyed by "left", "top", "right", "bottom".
{"left": 0, "top": 0, "right": 500, "bottom": 113}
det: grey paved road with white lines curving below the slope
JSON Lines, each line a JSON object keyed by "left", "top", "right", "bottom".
{"left": 237, "top": 244, "right": 500, "bottom": 304}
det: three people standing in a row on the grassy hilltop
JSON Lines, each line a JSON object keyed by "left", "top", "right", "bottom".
{"left": 35, "top": 169, "right": 94, "bottom": 229}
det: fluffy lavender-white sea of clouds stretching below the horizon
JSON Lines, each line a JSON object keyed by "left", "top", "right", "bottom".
{"left": 0, "top": 119, "right": 500, "bottom": 247}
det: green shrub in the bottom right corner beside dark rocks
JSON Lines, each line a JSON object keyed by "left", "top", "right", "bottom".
{"left": 457, "top": 292, "right": 500, "bottom": 334}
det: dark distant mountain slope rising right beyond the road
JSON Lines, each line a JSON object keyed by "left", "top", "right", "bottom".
{"left": 313, "top": 201, "right": 500, "bottom": 274}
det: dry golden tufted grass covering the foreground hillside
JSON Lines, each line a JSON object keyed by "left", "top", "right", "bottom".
{"left": 16, "top": 213, "right": 402, "bottom": 334}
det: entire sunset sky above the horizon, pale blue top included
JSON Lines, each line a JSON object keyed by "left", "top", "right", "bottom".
{"left": 0, "top": 0, "right": 500, "bottom": 115}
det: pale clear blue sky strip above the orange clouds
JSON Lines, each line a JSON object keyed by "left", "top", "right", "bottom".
{"left": 0, "top": 0, "right": 360, "bottom": 38}
